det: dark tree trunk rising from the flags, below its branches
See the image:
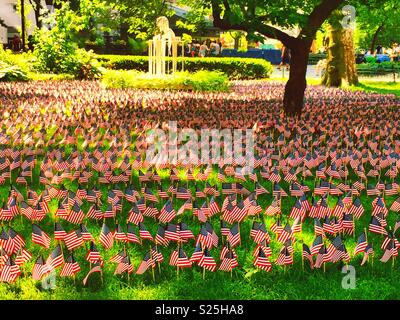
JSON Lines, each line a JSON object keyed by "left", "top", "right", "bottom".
{"left": 283, "top": 40, "right": 311, "bottom": 116}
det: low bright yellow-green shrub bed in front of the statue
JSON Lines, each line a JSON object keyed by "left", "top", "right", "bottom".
{"left": 103, "top": 70, "right": 229, "bottom": 92}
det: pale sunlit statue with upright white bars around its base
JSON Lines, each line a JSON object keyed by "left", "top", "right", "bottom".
{"left": 149, "top": 17, "right": 184, "bottom": 76}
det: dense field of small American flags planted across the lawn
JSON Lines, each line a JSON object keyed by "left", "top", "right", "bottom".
{"left": 0, "top": 81, "right": 400, "bottom": 284}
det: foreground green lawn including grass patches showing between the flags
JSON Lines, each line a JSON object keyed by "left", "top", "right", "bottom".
{"left": 0, "top": 166, "right": 400, "bottom": 300}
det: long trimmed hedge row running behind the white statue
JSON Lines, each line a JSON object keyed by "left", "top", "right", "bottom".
{"left": 97, "top": 55, "right": 272, "bottom": 80}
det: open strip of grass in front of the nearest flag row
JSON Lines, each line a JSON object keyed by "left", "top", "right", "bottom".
{"left": 6, "top": 268, "right": 400, "bottom": 300}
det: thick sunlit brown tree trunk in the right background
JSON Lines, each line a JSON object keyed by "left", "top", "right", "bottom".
{"left": 321, "top": 14, "right": 358, "bottom": 87}
